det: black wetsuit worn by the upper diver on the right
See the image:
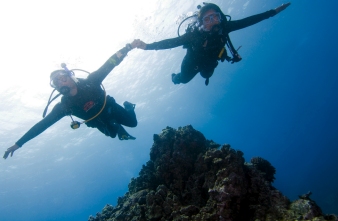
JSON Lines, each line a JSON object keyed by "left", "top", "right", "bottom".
{"left": 145, "top": 10, "right": 276, "bottom": 84}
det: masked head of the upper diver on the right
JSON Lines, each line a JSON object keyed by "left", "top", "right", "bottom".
{"left": 198, "top": 3, "right": 226, "bottom": 31}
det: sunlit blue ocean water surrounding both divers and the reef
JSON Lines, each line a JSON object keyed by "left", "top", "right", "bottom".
{"left": 0, "top": 0, "right": 338, "bottom": 221}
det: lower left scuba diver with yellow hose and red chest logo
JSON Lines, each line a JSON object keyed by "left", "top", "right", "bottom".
{"left": 3, "top": 40, "right": 139, "bottom": 159}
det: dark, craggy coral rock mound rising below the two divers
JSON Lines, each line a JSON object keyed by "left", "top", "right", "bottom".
{"left": 89, "top": 125, "right": 338, "bottom": 221}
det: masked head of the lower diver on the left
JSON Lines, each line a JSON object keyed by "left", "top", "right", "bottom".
{"left": 50, "top": 70, "right": 78, "bottom": 95}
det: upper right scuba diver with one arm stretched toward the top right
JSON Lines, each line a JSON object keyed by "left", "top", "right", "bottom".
{"left": 137, "top": 2, "right": 291, "bottom": 85}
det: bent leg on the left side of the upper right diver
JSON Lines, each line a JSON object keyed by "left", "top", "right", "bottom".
{"left": 172, "top": 55, "right": 199, "bottom": 84}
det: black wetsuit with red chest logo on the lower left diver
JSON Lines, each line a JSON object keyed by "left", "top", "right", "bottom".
{"left": 16, "top": 47, "right": 137, "bottom": 147}
